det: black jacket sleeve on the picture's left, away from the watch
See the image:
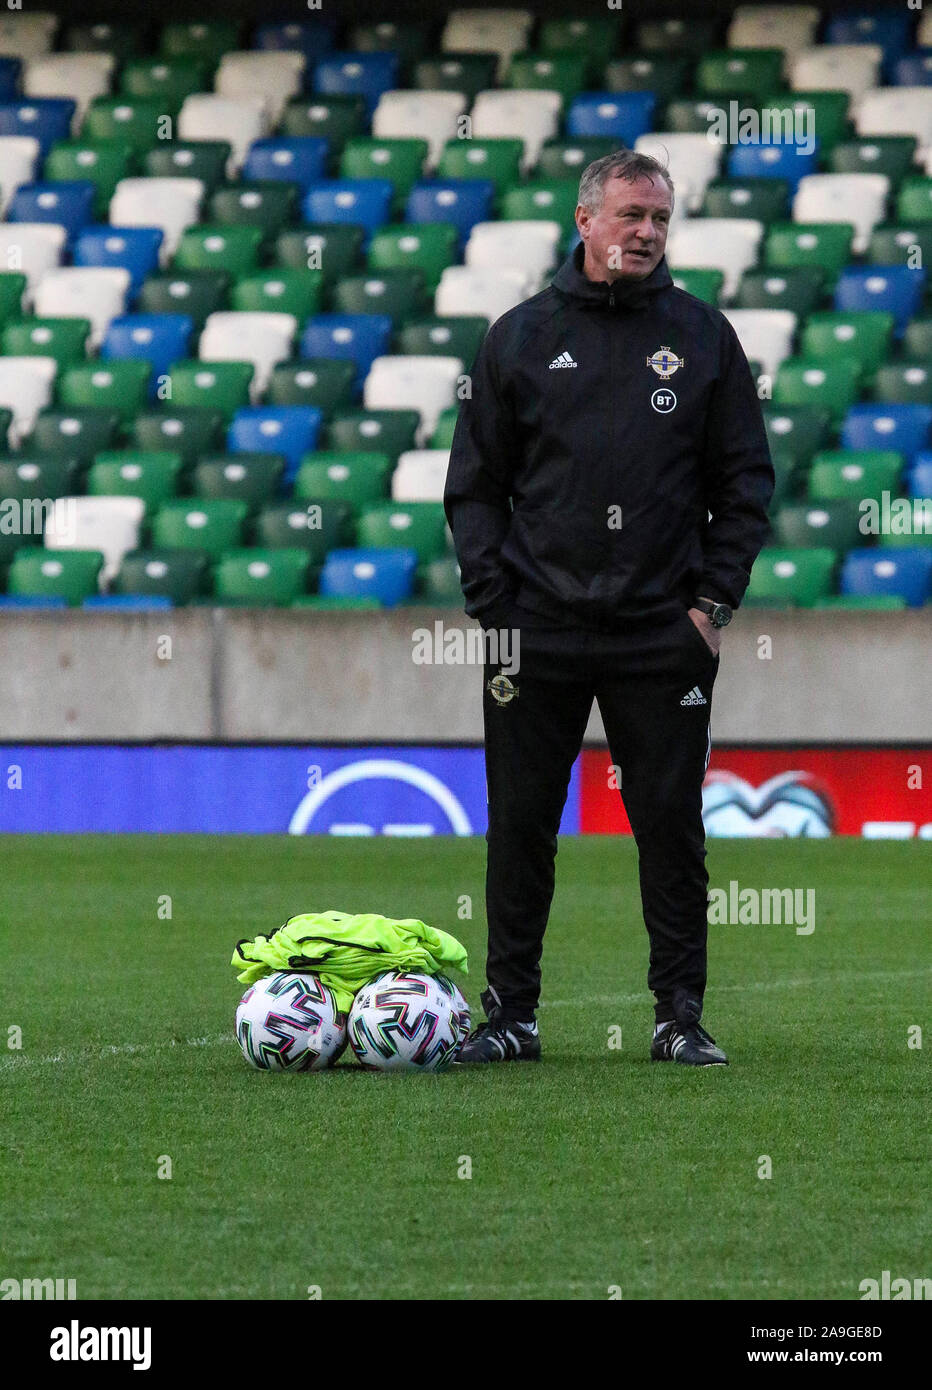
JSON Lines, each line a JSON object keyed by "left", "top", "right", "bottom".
{"left": 443, "top": 324, "right": 518, "bottom": 627}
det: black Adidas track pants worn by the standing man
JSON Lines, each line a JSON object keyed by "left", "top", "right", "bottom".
{"left": 483, "top": 607, "right": 718, "bottom": 1022}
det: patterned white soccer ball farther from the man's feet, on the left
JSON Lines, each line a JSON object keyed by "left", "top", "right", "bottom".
{"left": 236, "top": 970, "right": 346, "bottom": 1072}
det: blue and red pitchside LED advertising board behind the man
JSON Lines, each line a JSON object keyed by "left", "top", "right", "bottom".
{"left": 0, "top": 744, "right": 932, "bottom": 840}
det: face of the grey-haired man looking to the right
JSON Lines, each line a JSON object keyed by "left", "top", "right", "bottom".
{"left": 576, "top": 175, "right": 672, "bottom": 281}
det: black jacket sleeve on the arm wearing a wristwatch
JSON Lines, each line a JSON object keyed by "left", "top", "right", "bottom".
{"left": 696, "top": 320, "right": 774, "bottom": 607}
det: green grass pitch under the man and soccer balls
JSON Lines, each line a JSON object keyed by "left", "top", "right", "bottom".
{"left": 0, "top": 835, "right": 932, "bottom": 1300}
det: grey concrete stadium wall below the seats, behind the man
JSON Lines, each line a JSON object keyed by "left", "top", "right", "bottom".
{"left": 0, "top": 607, "right": 932, "bottom": 744}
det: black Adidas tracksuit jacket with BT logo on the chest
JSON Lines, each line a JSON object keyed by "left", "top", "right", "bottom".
{"left": 443, "top": 243, "right": 774, "bottom": 631}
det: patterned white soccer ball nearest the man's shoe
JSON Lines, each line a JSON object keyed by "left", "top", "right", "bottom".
{"left": 349, "top": 970, "right": 460, "bottom": 1072}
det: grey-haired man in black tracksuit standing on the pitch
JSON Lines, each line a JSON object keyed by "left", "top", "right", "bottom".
{"left": 444, "top": 150, "right": 774, "bottom": 1066}
